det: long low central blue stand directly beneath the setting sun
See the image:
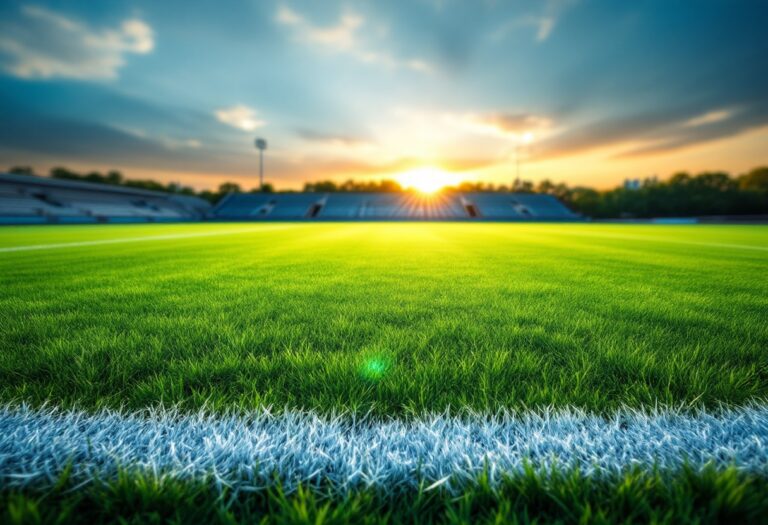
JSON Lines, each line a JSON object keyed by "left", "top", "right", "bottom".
{"left": 211, "top": 192, "right": 580, "bottom": 221}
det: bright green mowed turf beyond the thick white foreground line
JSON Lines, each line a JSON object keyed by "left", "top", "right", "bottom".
{"left": 0, "top": 223, "right": 768, "bottom": 416}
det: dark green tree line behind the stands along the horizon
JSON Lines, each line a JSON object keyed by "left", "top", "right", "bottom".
{"left": 9, "top": 166, "right": 768, "bottom": 218}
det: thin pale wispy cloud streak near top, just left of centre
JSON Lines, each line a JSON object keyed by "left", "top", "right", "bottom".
{"left": 275, "top": 5, "right": 432, "bottom": 72}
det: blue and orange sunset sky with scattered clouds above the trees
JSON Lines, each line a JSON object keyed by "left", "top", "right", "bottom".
{"left": 0, "top": 0, "right": 768, "bottom": 189}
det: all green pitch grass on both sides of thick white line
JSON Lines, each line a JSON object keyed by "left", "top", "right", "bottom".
{"left": 0, "top": 223, "right": 768, "bottom": 524}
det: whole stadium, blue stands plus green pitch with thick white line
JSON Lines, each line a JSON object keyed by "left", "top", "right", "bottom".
{"left": 0, "top": 170, "right": 768, "bottom": 522}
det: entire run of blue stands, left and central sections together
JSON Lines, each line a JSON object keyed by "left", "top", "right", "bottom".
{"left": 0, "top": 174, "right": 579, "bottom": 224}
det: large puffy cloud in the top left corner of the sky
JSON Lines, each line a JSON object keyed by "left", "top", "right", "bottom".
{"left": 0, "top": 6, "right": 154, "bottom": 80}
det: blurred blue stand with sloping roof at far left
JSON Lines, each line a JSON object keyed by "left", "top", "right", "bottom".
{"left": 0, "top": 174, "right": 210, "bottom": 224}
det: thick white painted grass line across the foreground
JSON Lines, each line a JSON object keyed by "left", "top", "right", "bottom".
{"left": 0, "top": 405, "right": 768, "bottom": 491}
